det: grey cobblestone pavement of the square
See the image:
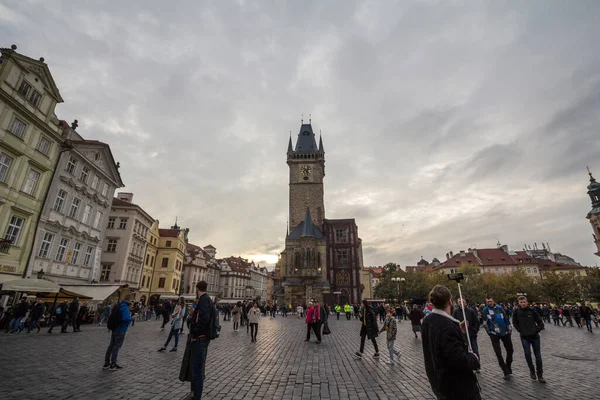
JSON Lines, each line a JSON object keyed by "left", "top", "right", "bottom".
{"left": 0, "top": 316, "right": 600, "bottom": 400}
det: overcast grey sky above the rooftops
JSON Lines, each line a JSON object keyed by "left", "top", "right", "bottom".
{"left": 0, "top": 0, "right": 600, "bottom": 266}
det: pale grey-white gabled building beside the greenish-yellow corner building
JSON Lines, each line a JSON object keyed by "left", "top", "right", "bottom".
{"left": 30, "top": 121, "right": 123, "bottom": 284}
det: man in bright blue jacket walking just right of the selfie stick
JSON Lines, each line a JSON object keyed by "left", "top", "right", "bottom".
{"left": 483, "top": 296, "right": 514, "bottom": 380}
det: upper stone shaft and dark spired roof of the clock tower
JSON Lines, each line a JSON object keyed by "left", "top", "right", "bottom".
{"left": 287, "top": 123, "right": 325, "bottom": 230}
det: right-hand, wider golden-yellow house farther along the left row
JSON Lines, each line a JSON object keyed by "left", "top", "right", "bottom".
{"left": 151, "top": 223, "right": 188, "bottom": 296}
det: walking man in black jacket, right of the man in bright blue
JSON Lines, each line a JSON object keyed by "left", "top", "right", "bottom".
{"left": 513, "top": 296, "right": 546, "bottom": 383}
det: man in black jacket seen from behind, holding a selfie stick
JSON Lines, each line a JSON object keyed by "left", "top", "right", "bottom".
{"left": 421, "top": 285, "right": 481, "bottom": 400}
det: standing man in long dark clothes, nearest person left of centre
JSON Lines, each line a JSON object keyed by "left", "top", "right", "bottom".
{"left": 190, "top": 281, "right": 220, "bottom": 400}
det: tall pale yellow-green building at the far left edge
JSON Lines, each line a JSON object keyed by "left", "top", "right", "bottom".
{"left": 0, "top": 45, "right": 65, "bottom": 282}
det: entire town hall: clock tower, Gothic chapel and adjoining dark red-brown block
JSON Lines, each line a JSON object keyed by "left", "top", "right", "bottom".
{"left": 274, "top": 123, "right": 364, "bottom": 306}
